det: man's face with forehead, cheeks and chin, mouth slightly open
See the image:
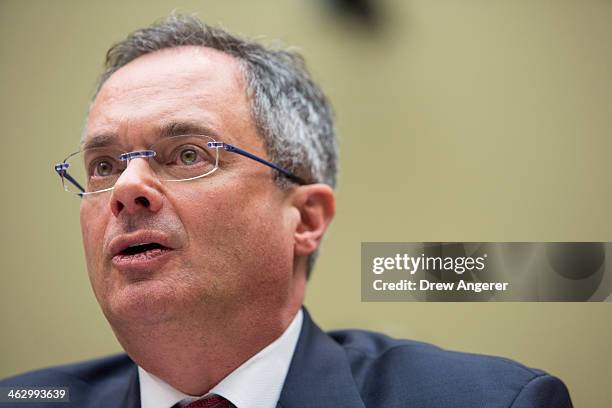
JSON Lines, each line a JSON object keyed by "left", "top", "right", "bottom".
{"left": 81, "top": 47, "right": 296, "bottom": 325}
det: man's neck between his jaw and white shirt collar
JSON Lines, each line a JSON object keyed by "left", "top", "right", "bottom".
{"left": 113, "top": 299, "right": 302, "bottom": 396}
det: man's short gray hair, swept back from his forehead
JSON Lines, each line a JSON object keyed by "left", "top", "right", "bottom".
{"left": 94, "top": 14, "right": 338, "bottom": 277}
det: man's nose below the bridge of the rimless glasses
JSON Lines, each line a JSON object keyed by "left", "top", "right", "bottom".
{"left": 110, "top": 158, "right": 164, "bottom": 217}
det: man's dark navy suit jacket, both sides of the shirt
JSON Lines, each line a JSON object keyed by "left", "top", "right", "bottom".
{"left": 0, "top": 310, "right": 572, "bottom": 408}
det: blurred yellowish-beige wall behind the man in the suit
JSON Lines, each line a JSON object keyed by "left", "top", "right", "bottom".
{"left": 0, "top": 0, "right": 612, "bottom": 407}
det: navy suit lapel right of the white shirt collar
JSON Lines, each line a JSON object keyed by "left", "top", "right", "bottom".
{"left": 277, "top": 308, "right": 364, "bottom": 408}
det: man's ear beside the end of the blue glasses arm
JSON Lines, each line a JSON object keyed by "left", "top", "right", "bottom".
{"left": 291, "top": 184, "right": 336, "bottom": 256}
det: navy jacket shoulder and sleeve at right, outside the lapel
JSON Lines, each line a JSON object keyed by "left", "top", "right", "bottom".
{"left": 328, "top": 330, "right": 571, "bottom": 407}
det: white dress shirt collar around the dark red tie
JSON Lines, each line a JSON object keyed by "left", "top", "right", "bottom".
{"left": 138, "top": 309, "right": 303, "bottom": 408}
